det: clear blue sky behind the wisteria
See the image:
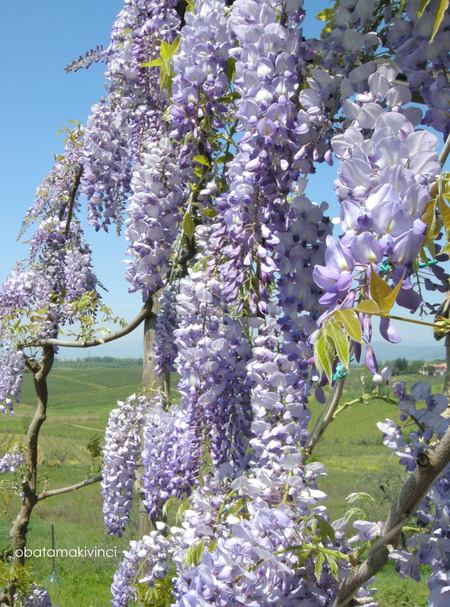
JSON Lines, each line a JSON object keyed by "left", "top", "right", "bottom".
{"left": 0, "top": 0, "right": 442, "bottom": 357}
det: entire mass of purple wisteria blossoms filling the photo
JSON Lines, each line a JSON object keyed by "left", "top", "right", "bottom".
{"left": 0, "top": 0, "right": 450, "bottom": 607}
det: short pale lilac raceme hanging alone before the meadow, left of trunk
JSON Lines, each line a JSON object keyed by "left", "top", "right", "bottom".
{"left": 101, "top": 394, "right": 150, "bottom": 536}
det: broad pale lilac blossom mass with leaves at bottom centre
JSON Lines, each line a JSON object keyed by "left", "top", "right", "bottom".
{"left": 173, "top": 464, "right": 375, "bottom": 607}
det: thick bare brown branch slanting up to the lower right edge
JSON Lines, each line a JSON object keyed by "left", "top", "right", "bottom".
{"left": 333, "top": 430, "right": 450, "bottom": 607}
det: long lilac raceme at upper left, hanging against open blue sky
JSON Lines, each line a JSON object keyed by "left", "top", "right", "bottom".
{"left": 81, "top": 0, "right": 180, "bottom": 230}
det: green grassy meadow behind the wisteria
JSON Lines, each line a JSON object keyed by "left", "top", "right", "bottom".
{"left": 0, "top": 367, "right": 442, "bottom": 607}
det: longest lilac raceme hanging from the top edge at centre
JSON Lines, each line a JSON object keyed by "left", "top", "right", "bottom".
{"left": 207, "top": 0, "right": 324, "bottom": 313}
